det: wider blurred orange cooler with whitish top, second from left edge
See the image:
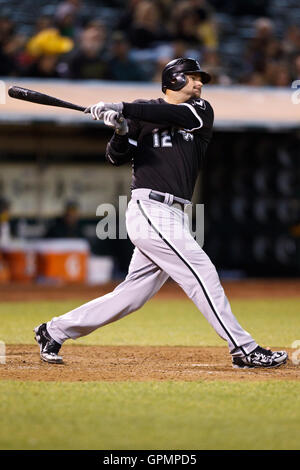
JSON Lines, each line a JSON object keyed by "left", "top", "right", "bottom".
{"left": 37, "top": 239, "right": 89, "bottom": 283}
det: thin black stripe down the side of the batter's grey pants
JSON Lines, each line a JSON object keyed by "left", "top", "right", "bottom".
{"left": 136, "top": 200, "right": 247, "bottom": 355}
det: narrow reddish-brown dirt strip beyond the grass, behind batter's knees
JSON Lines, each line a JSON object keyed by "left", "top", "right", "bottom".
{"left": 0, "top": 279, "right": 300, "bottom": 302}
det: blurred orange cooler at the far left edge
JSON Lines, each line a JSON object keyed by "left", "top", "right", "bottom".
{"left": 2, "top": 240, "right": 36, "bottom": 282}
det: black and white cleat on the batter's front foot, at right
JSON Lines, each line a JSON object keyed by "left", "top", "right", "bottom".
{"left": 232, "top": 346, "right": 288, "bottom": 369}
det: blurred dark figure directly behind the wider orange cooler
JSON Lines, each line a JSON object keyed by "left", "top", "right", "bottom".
{"left": 45, "top": 201, "right": 84, "bottom": 238}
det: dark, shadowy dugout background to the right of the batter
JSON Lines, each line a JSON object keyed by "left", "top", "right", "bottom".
{"left": 202, "top": 130, "right": 300, "bottom": 276}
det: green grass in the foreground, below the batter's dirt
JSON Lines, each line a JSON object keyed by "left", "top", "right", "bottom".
{"left": 0, "top": 381, "right": 300, "bottom": 450}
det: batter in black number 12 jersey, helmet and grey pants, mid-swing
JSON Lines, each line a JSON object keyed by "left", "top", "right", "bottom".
{"left": 34, "top": 58, "right": 288, "bottom": 368}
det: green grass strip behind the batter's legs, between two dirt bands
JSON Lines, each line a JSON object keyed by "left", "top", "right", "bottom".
{"left": 0, "top": 299, "right": 300, "bottom": 347}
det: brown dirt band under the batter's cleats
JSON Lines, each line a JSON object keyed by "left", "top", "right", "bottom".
{"left": 0, "top": 345, "right": 300, "bottom": 382}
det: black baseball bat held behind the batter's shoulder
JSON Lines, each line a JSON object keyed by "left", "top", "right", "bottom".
{"left": 8, "top": 86, "right": 87, "bottom": 111}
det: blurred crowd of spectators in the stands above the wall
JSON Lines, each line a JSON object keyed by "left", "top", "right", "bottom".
{"left": 0, "top": 0, "right": 300, "bottom": 86}
